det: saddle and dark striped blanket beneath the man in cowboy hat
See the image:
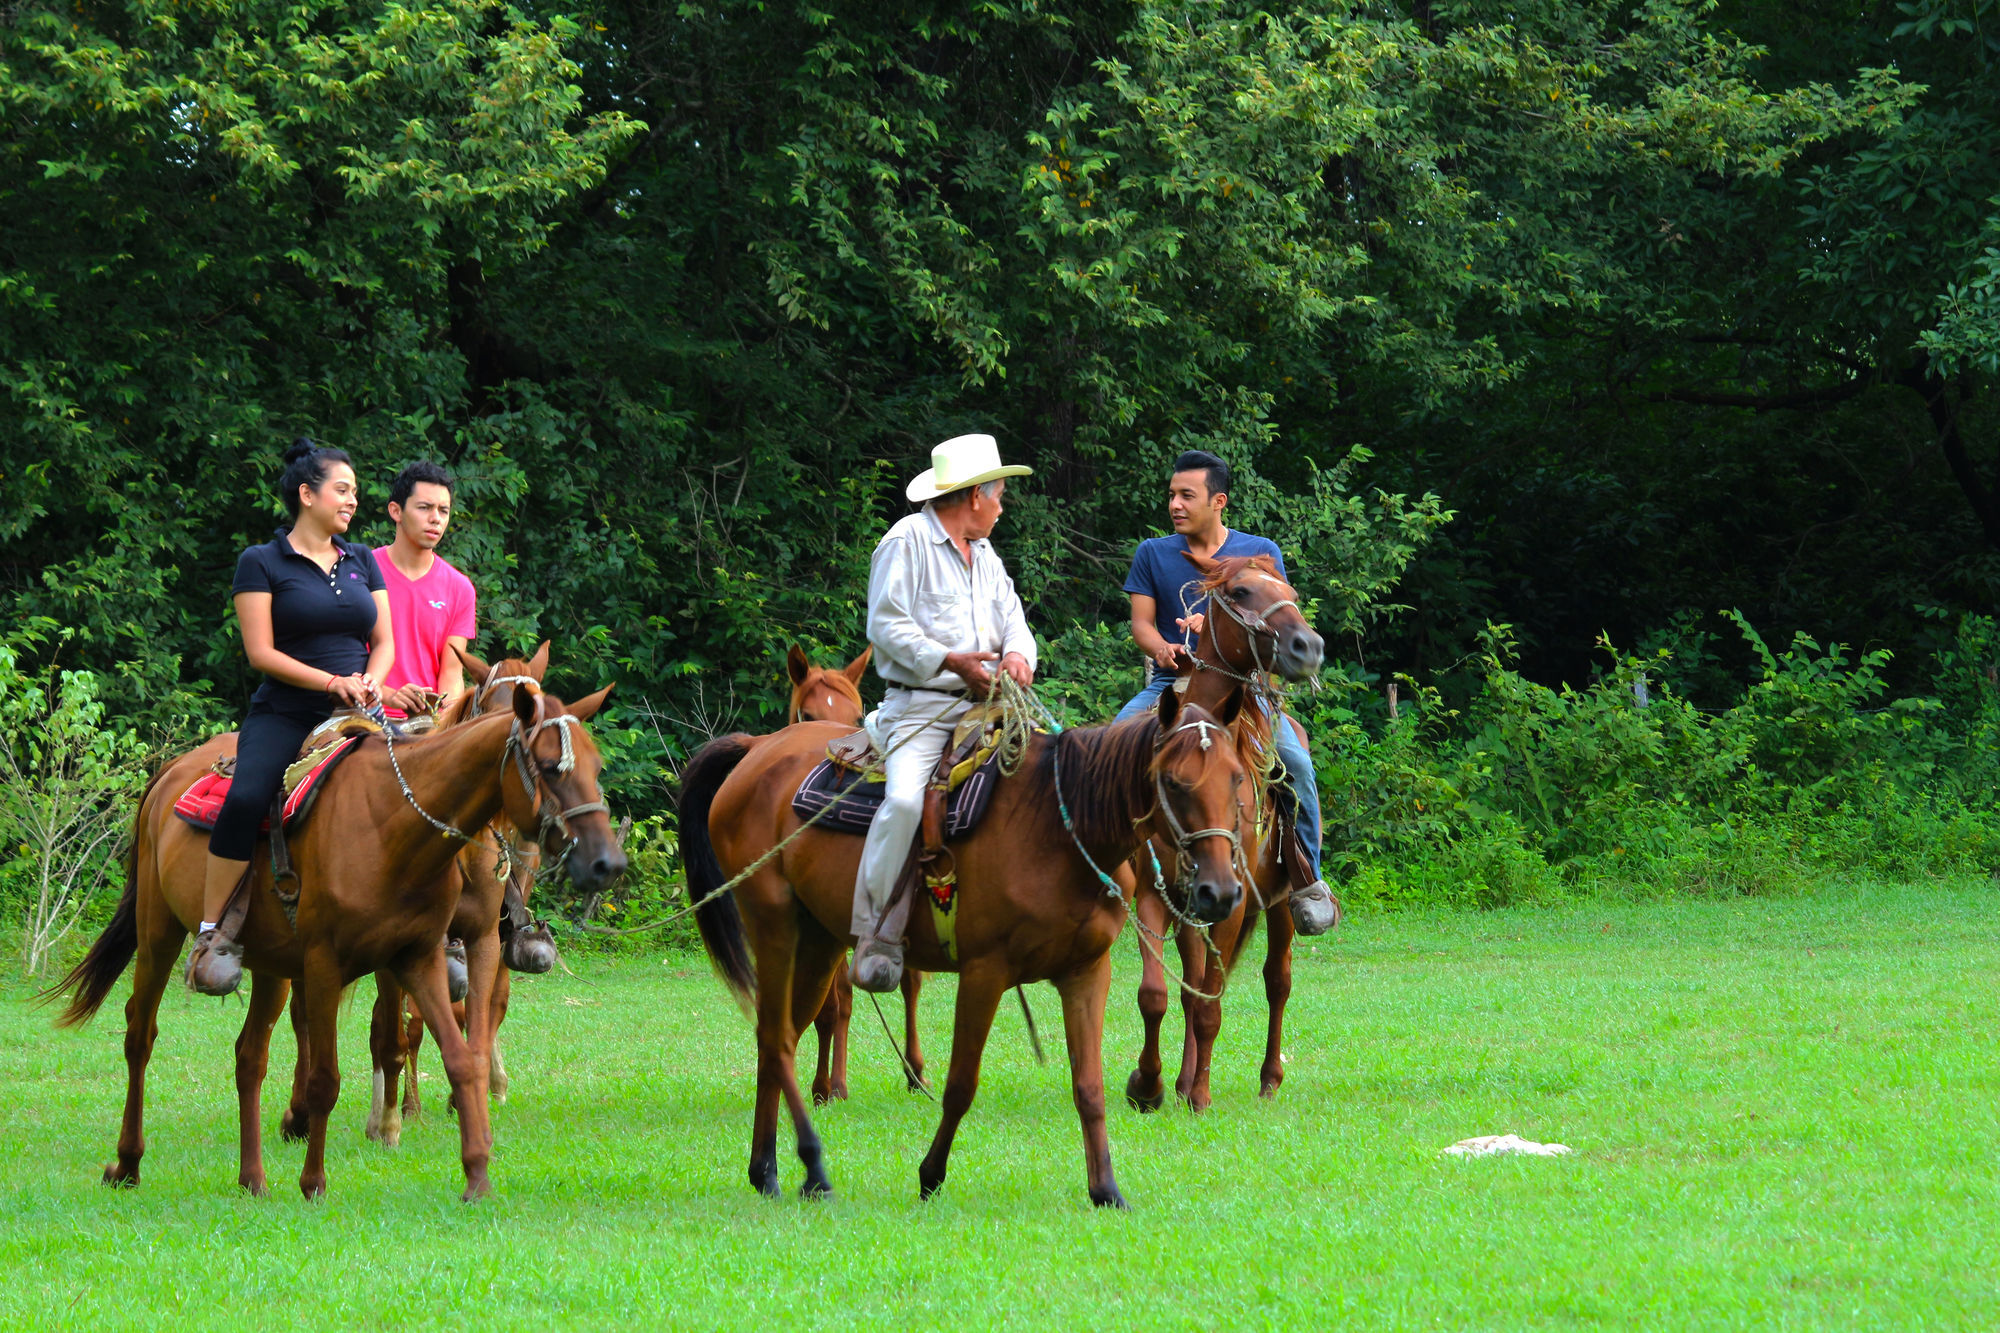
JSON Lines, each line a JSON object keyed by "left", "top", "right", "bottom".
{"left": 792, "top": 705, "right": 1032, "bottom": 961}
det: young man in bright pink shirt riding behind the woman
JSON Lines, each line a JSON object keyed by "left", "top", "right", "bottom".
{"left": 374, "top": 462, "right": 478, "bottom": 717}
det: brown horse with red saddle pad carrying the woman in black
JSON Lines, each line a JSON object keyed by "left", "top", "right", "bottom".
{"left": 52, "top": 691, "right": 622, "bottom": 1199}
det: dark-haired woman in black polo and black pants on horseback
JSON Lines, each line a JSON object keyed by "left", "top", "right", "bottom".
{"left": 188, "top": 440, "right": 396, "bottom": 995}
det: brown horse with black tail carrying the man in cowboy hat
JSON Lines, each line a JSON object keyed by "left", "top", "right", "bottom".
{"left": 680, "top": 693, "right": 1244, "bottom": 1207}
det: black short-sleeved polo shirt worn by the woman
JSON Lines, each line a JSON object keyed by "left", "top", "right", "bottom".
{"left": 230, "top": 528, "right": 382, "bottom": 713}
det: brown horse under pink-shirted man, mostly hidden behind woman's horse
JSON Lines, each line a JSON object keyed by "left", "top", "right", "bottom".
{"left": 338, "top": 640, "right": 566, "bottom": 1147}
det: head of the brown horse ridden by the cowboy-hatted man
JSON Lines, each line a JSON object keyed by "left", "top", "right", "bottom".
{"left": 1152, "top": 691, "right": 1248, "bottom": 925}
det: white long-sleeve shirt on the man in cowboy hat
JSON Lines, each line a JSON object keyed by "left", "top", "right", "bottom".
{"left": 868, "top": 504, "right": 1036, "bottom": 691}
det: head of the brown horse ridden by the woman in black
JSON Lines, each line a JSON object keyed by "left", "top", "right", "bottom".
{"left": 496, "top": 676, "right": 626, "bottom": 893}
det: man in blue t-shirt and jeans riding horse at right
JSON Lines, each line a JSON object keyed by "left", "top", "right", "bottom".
{"left": 1118, "top": 448, "right": 1334, "bottom": 935}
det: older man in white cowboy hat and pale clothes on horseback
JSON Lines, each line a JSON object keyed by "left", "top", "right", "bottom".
{"left": 854, "top": 434, "right": 1036, "bottom": 991}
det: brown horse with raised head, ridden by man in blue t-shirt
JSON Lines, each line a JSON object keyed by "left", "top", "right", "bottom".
{"left": 1126, "top": 556, "right": 1326, "bottom": 1111}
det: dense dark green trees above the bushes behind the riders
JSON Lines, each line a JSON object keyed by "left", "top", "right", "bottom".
{"left": 0, "top": 0, "right": 2000, "bottom": 752}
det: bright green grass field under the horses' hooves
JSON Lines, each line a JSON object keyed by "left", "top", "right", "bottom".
{"left": 0, "top": 883, "right": 2000, "bottom": 1329}
